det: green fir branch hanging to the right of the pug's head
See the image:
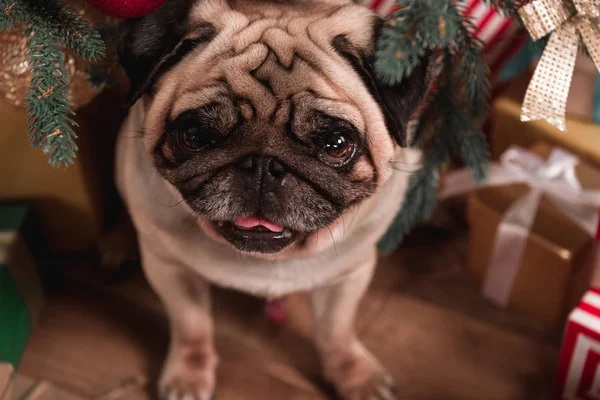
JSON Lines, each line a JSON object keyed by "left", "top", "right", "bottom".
{"left": 375, "top": 0, "right": 527, "bottom": 252}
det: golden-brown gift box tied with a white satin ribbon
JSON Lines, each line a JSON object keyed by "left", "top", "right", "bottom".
{"left": 448, "top": 143, "right": 600, "bottom": 327}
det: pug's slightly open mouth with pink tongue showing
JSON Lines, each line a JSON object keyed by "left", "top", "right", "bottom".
{"left": 214, "top": 216, "right": 300, "bottom": 253}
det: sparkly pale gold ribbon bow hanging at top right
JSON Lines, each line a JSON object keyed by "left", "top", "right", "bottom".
{"left": 519, "top": 0, "right": 600, "bottom": 131}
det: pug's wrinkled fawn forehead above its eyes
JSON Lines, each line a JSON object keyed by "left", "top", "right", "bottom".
{"left": 162, "top": 0, "right": 373, "bottom": 122}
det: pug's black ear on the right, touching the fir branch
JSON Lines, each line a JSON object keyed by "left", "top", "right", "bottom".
{"left": 332, "top": 17, "right": 431, "bottom": 147}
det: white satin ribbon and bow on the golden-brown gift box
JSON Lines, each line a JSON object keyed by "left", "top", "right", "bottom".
{"left": 440, "top": 147, "right": 600, "bottom": 306}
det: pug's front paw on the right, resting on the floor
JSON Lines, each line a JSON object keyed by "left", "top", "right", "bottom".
{"left": 326, "top": 346, "right": 400, "bottom": 400}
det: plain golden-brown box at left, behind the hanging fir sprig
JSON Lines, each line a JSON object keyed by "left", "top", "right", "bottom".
{"left": 0, "top": 89, "right": 126, "bottom": 253}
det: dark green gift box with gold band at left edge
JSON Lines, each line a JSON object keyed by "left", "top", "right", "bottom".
{"left": 0, "top": 202, "right": 47, "bottom": 368}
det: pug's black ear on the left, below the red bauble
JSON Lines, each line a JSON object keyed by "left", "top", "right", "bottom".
{"left": 118, "top": 0, "right": 215, "bottom": 106}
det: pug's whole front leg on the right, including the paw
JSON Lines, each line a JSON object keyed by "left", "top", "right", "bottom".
{"left": 312, "top": 255, "right": 397, "bottom": 400}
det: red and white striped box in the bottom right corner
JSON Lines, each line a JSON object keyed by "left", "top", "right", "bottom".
{"left": 555, "top": 289, "right": 600, "bottom": 400}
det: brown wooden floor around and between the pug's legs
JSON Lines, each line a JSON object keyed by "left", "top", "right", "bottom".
{"left": 21, "top": 220, "right": 560, "bottom": 400}
